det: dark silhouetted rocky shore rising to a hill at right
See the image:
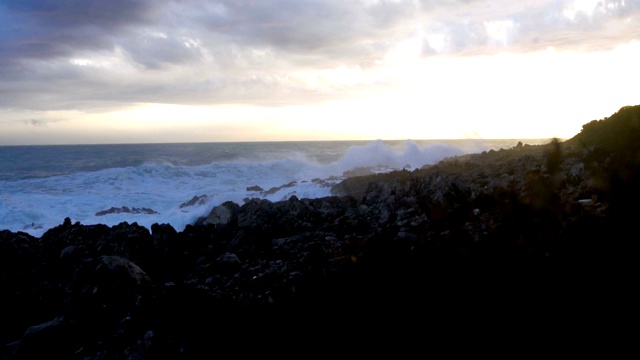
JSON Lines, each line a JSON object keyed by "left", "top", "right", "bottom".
{"left": 0, "top": 106, "right": 640, "bottom": 359}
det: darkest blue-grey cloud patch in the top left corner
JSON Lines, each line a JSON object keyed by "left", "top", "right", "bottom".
{"left": 0, "top": 0, "right": 156, "bottom": 58}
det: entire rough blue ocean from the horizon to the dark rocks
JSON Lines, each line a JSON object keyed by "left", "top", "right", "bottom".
{"left": 0, "top": 139, "right": 550, "bottom": 237}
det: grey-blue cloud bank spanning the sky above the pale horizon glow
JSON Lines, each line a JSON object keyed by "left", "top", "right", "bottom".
{"left": 0, "top": 0, "right": 640, "bottom": 114}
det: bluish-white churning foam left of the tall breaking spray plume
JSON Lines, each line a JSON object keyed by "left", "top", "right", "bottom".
{"left": 0, "top": 160, "right": 330, "bottom": 236}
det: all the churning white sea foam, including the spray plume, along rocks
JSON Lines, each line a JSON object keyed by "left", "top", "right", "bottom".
{"left": 0, "top": 141, "right": 540, "bottom": 236}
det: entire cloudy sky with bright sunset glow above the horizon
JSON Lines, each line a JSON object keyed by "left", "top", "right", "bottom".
{"left": 0, "top": 0, "right": 640, "bottom": 145}
